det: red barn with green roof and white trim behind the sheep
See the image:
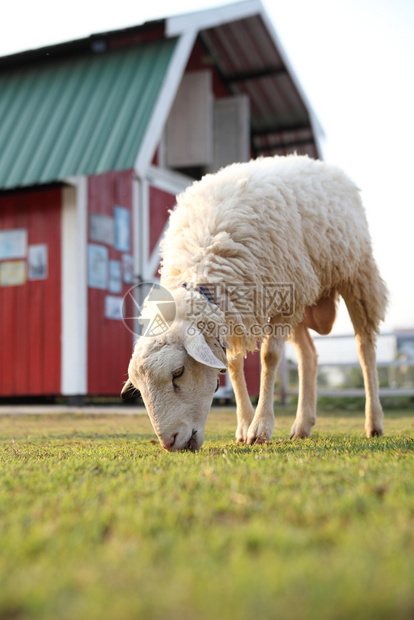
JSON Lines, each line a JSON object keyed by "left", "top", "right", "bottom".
{"left": 0, "top": 0, "right": 320, "bottom": 397}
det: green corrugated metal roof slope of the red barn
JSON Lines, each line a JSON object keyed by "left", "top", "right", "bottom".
{"left": 0, "top": 39, "right": 177, "bottom": 189}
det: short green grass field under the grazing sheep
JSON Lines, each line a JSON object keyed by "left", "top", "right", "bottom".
{"left": 0, "top": 408, "right": 414, "bottom": 620}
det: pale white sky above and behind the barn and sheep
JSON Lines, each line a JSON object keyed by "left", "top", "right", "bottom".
{"left": 0, "top": 0, "right": 414, "bottom": 333}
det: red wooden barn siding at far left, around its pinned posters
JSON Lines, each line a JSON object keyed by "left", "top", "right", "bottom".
{"left": 0, "top": 188, "right": 62, "bottom": 396}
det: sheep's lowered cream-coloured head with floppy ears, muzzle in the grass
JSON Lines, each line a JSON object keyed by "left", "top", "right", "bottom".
{"left": 122, "top": 320, "right": 227, "bottom": 450}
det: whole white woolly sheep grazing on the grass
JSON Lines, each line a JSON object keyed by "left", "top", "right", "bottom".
{"left": 123, "top": 156, "right": 387, "bottom": 450}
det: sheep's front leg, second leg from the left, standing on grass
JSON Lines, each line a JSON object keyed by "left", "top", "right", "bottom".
{"left": 247, "top": 336, "right": 285, "bottom": 444}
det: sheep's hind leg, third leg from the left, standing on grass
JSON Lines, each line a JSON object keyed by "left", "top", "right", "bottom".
{"left": 290, "top": 323, "right": 318, "bottom": 439}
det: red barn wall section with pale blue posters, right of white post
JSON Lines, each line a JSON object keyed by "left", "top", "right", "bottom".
{"left": 88, "top": 171, "right": 133, "bottom": 395}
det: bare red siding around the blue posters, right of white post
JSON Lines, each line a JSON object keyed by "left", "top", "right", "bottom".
{"left": 87, "top": 171, "right": 133, "bottom": 395}
